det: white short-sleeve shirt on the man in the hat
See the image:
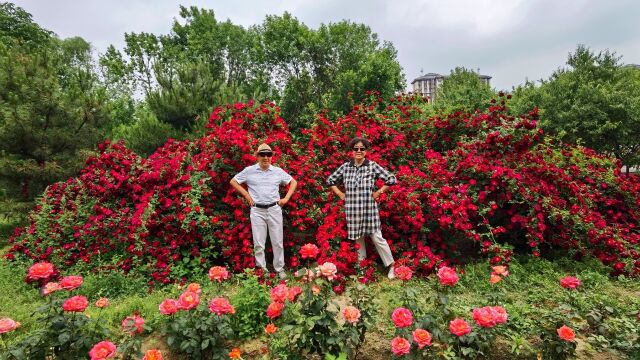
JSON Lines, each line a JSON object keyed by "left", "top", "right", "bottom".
{"left": 234, "top": 164, "right": 293, "bottom": 204}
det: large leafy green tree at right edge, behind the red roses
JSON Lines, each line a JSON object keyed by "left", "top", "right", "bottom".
{"left": 541, "top": 45, "right": 640, "bottom": 170}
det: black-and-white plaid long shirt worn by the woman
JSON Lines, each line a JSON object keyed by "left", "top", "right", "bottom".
{"left": 327, "top": 159, "right": 396, "bottom": 240}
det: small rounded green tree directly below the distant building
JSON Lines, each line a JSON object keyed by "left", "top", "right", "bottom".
{"left": 434, "top": 67, "right": 495, "bottom": 113}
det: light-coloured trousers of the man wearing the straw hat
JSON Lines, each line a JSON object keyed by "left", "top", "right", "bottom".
{"left": 250, "top": 205, "right": 284, "bottom": 272}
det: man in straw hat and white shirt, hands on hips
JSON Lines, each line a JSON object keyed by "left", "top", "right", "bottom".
{"left": 231, "top": 144, "right": 298, "bottom": 279}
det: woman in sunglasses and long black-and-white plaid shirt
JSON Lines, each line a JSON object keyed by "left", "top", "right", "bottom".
{"left": 327, "top": 137, "right": 396, "bottom": 279}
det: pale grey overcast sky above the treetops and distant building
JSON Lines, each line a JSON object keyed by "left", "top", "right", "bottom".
{"left": 14, "top": 0, "right": 640, "bottom": 89}
